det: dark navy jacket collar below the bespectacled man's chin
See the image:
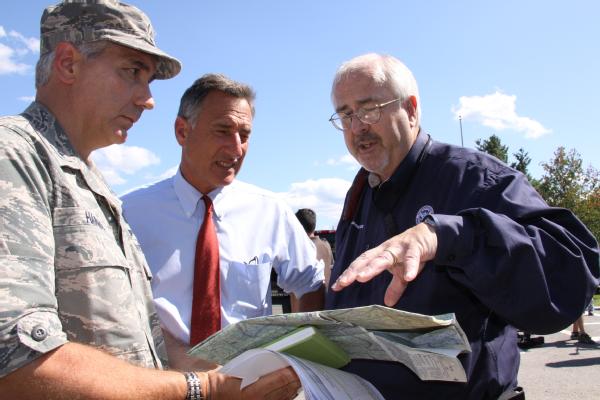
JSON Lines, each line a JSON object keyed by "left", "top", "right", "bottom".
{"left": 372, "top": 130, "right": 429, "bottom": 212}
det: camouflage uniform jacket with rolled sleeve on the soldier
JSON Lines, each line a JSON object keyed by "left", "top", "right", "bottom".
{"left": 0, "top": 103, "right": 166, "bottom": 377}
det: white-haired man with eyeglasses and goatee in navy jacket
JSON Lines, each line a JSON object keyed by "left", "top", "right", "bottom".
{"left": 326, "top": 54, "right": 600, "bottom": 400}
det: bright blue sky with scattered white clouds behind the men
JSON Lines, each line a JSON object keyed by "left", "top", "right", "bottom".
{"left": 0, "top": 0, "right": 600, "bottom": 228}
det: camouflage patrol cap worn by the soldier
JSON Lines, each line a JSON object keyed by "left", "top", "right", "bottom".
{"left": 40, "top": 0, "right": 181, "bottom": 79}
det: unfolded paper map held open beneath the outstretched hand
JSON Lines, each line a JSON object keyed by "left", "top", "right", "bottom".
{"left": 189, "top": 305, "right": 471, "bottom": 382}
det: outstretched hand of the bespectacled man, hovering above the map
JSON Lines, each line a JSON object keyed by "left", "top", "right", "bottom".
{"left": 331, "top": 223, "right": 437, "bottom": 307}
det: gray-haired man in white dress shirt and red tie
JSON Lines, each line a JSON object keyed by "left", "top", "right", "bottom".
{"left": 123, "top": 74, "right": 324, "bottom": 366}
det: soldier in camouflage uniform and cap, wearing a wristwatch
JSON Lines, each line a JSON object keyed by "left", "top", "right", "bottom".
{"left": 0, "top": 0, "right": 299, "bottom": 400}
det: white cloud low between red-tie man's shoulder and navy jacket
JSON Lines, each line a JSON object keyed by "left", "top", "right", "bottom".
{"left": 279, "top": 178, "right": 352, "bottom": 229}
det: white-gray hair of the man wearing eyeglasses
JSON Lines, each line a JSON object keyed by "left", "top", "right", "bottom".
{"left": 331, "top": 53, "right": 421, "bottom": 123}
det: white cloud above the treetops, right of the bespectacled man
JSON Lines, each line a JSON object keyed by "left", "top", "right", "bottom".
{"left": 452, "top": 91, "right": 550, "bottom": 139}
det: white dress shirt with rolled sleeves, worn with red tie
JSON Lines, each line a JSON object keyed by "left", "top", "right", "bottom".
{"left": 122, "top": 171, "right": 324, "bottom": 343}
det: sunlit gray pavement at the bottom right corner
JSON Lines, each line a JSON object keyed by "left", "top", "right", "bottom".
{"left": 519, "top": 308, "right": 600, "bottom": 400}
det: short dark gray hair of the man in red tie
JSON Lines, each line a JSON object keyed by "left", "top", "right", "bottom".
{"left": 177, "top": 74, "right": 256, "bottom": 128}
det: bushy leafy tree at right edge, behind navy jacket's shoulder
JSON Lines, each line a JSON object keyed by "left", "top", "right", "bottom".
{"left": 534, "top": 146, "right": 600, "bottom": 238}
